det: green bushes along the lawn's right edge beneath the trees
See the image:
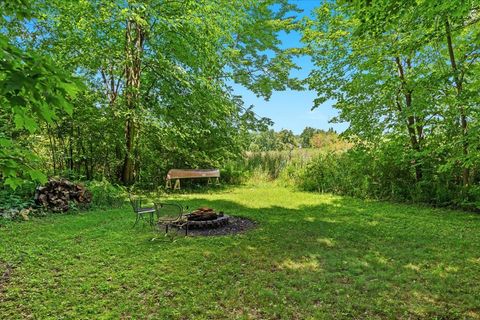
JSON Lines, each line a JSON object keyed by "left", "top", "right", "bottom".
{"left": 295, "top": 148, "right": 480, "bottom": 210}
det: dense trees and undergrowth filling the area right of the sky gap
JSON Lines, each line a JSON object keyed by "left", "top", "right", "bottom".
{"left": 303, "top": 0, "right": 480, "bottom": 210}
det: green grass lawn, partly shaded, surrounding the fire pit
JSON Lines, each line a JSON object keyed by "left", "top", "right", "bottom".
{"left": 0, "top": 185, "right": 480, "bottom": 319}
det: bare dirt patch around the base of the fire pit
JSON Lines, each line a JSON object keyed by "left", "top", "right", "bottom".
{"left": 160, "top": 216, "right": 257, "bottom": 237}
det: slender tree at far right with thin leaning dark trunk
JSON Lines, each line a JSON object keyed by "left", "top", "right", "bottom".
{"left": 344, "top": 0, "right": 480, "bottom": 186}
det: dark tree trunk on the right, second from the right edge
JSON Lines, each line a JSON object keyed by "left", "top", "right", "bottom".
{"left": 395, "top": 57, "right": 423, "bottom": 182}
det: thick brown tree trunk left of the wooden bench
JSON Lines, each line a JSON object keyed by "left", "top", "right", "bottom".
{"left": 121, "top": 20, "right": 145, "bottom": 185}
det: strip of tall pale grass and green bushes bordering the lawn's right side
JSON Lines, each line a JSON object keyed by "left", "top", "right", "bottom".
{"left": 235, "top": 148, "right": 480, "bottom": 210}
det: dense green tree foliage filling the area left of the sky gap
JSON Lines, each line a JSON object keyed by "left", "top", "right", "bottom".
{"left": 0, "top": 0, "right": 299, "bottom": 192}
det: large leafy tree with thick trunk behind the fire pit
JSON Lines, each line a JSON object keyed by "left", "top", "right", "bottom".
{"left": 4, "top": 0, "right": 300, "bottom": 184}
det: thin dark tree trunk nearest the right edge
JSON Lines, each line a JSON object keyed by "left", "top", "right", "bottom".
{"left": 445, "top": 19, "right": 470, "bottom": 186}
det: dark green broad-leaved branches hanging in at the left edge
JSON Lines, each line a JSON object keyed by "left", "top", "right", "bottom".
{"left": 0, "top": 0, "right": 79, "bottom": 189}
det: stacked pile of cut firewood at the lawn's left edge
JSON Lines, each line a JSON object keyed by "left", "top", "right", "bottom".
{"left": 35, "top": 179, "right": 92, "bottom": 212}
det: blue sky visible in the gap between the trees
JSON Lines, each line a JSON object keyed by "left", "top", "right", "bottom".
{"left": 233, "top": 0, "right": 347, "bottom": 134}
